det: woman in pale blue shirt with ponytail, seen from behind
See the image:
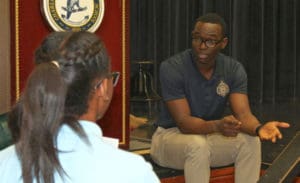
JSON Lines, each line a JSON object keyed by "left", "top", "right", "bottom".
{"left": 0, "top": 32, "right": 159, "bottom": 183}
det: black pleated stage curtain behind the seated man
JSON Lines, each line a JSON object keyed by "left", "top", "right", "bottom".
{"left": 130, "top": 0, "right": 300, "bottom": 103}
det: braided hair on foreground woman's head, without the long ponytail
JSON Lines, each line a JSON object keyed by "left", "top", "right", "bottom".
{"left": 58, "top": 32, "right": 110, "bottom": 121}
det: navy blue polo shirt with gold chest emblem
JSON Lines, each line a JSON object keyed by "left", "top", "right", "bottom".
{"left": 157, "top": 49, "right": 247, "bottom": 128}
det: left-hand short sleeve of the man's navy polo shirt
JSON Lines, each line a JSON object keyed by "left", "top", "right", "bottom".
{"left": 159, "top": 60, "right": 185, "bottom": 101}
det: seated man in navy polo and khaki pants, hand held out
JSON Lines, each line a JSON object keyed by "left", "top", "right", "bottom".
{"left": 151, "top": 13, "right": 289, "bottom": 183}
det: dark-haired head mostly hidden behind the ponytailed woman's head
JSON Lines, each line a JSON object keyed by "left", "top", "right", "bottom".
{"left": 34, "top": 32, "right": 70, "bottom": 64}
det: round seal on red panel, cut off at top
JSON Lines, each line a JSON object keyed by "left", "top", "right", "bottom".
{"left": 42, "top": 0, "right": 104, "bottom": 32}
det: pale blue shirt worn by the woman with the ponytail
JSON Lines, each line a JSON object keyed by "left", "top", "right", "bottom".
{"left": 0, "top": 121, "right": 160, "bottom": 183}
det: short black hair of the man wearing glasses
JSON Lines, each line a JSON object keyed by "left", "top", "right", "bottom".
{"left": 194, "top": 13, "right": 227, "bottom": 36}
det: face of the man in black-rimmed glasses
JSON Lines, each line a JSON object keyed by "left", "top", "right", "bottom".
{"left": 192, "top": 22, "right": 227, "bottom": 67}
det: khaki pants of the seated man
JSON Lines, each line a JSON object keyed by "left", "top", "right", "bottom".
{"left": 150, "top": 127, "right": 261, "bottom": 183}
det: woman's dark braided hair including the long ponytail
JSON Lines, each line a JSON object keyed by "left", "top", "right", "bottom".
{"left": 11, "top": 31, "right": 110, "bottom": 183}
